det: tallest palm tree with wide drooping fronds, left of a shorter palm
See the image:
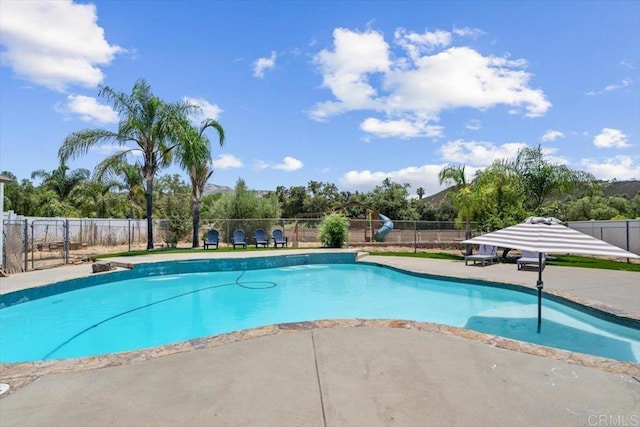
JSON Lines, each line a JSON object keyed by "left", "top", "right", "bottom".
{"left": 58, "top": 79, "right": 196, "bottom": 250}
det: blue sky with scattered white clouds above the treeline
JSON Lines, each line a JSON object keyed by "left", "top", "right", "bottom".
{"left": 0, "top": 0, "right": 640, "bottom": 194}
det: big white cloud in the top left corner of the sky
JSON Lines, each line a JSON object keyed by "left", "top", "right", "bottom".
{"left": 0, "top": 0, "right": 124, "bottom": 91}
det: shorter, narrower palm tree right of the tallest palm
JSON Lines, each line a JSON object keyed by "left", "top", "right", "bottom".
{"left": 176, "top": 119, "right": 224, "bottom": 248}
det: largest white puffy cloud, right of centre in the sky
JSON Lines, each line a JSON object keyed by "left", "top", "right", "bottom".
{"left": 309, "top": 28, "right": 551, "bottom": 130}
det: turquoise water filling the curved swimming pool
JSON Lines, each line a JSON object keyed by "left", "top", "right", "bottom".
{"left": 0, "top": 263, "right": 640, "bottom": 362}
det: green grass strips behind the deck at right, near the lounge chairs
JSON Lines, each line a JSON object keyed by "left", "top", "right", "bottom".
{"left": 369, "top": 252, "right": 640, "bottom": 272}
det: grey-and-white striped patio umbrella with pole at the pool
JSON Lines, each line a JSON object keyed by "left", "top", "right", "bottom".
{"left": 462, "top": 217, "right": 640, "bottom": 332}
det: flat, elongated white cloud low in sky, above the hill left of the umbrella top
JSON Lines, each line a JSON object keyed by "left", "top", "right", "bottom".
{"left": 440, "top": 139, "right": 527, "bottom": 166}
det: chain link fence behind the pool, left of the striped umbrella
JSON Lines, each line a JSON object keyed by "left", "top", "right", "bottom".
{"left": 0, "top": 217, "right": 464, "bottom": 273}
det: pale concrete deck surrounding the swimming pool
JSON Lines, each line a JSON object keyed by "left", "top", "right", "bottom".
{"left": 0, "top": 250, "right": 640, "bottom": 426}
